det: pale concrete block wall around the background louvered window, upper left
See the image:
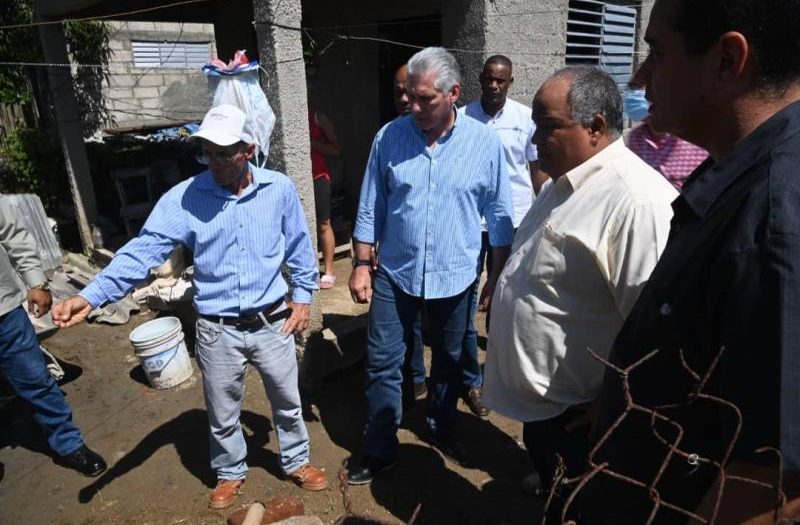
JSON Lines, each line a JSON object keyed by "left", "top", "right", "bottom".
{"left": 105, "top": 22, "right": 216, "bottom": 129}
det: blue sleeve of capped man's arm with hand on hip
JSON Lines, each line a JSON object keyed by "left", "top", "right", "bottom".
{"left": 283, "top": 183, "right": 318, "bottom": 304}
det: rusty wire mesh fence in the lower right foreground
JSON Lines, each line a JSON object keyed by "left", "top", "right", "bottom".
{"left": 542, "top": 348, "right": 786, "bottom": 525}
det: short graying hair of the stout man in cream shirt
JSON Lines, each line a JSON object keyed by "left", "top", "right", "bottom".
{"left": 550, "top": 66, "right": 622, "bottom": 139}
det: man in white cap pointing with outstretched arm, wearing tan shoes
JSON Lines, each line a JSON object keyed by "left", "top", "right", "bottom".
{"left": 53, "top": 105, "right": 328, "bottom": 509}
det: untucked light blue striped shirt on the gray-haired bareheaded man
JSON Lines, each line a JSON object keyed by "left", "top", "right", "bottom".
{"left": 354, "top": 111, "right": 514, "bottom": 299}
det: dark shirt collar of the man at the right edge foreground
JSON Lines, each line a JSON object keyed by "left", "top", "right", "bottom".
{"left": 682, "top": 102, "right": 800, "bottom": 217}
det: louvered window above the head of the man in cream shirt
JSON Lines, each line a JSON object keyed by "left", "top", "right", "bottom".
{"left": 566, "top": 0, "right": 636, "bottom": 86}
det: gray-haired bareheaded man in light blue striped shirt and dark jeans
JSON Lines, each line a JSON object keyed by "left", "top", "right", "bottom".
{"left": 348, "top": 48, "right": 513, "bottom": 485}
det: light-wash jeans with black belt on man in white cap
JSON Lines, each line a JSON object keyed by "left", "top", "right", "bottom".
{"left": 196, "top": 304, "right": 309, "bottom": 479}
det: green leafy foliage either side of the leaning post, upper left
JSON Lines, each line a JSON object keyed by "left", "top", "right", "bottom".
{"left": 0, "top": 0, "right": 111, "bottom": 212}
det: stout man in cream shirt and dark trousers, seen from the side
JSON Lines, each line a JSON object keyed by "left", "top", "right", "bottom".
{"left": 484, "top": 67, "right": 678, "bottom": 507}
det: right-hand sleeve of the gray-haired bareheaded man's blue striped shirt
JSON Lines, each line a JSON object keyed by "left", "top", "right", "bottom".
{"left": 482, "top": 138, "right": 514, "bottom": 246}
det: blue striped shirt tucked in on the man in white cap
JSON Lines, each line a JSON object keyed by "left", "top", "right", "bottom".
{"left": 80, "top": 165, "right": 317, "bottom": 317}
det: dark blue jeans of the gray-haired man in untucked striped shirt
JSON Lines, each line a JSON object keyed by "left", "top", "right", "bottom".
{"left": 364, "top": 269, "right": 475, "bottom": 459}
